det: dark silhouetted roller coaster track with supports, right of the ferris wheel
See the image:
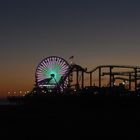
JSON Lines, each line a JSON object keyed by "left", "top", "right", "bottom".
{"left": 39, "top": 64, "right": 140, "bottom": 90}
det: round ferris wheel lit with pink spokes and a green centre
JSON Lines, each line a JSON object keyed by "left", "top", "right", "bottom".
{"left": 35, "top": 56, "right": 69, "bottom": 90}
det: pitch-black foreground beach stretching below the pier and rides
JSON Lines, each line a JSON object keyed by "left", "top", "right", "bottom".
{"left": 0, "top": 96, "right": 140, "bottom": 139}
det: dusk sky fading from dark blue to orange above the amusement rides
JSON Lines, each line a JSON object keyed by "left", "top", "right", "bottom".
{"left": 0, "top": 0, "right": 140, "bottom": 96}
